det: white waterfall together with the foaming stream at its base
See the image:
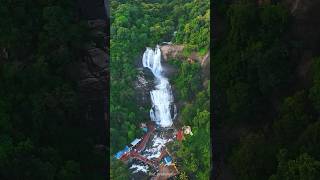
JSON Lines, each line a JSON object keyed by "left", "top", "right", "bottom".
{"left": 129, "top": 46, "right": 177, "bottom": 175}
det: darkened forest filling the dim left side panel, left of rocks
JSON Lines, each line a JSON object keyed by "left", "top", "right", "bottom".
{"left": 0, "top": 0, "right": 105, "bottom": 180}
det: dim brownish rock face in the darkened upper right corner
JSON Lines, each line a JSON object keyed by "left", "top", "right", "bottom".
{"left": 285, "top": 0, "right": 320, "bottom": 86}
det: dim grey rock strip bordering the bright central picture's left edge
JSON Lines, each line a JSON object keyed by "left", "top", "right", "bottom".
{"left": 77, "top": 0, "right": 109, "bottom": 165}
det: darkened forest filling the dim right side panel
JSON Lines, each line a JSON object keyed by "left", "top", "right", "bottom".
{"left": 212, "top": 0, "right": 320, "bottom": 180}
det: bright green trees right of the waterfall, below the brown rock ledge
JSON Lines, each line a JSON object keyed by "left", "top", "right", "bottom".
{"left": 173, "top": 62, "right": 211, "bottom": 179}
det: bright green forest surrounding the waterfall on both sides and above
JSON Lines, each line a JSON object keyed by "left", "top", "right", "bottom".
{"left": 110, "top": 0, "right": 210, "bottom": 179}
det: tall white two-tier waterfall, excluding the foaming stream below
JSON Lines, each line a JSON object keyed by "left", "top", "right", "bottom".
{"left": 142, "top": 46, "right": 176, "bottom": 127}
